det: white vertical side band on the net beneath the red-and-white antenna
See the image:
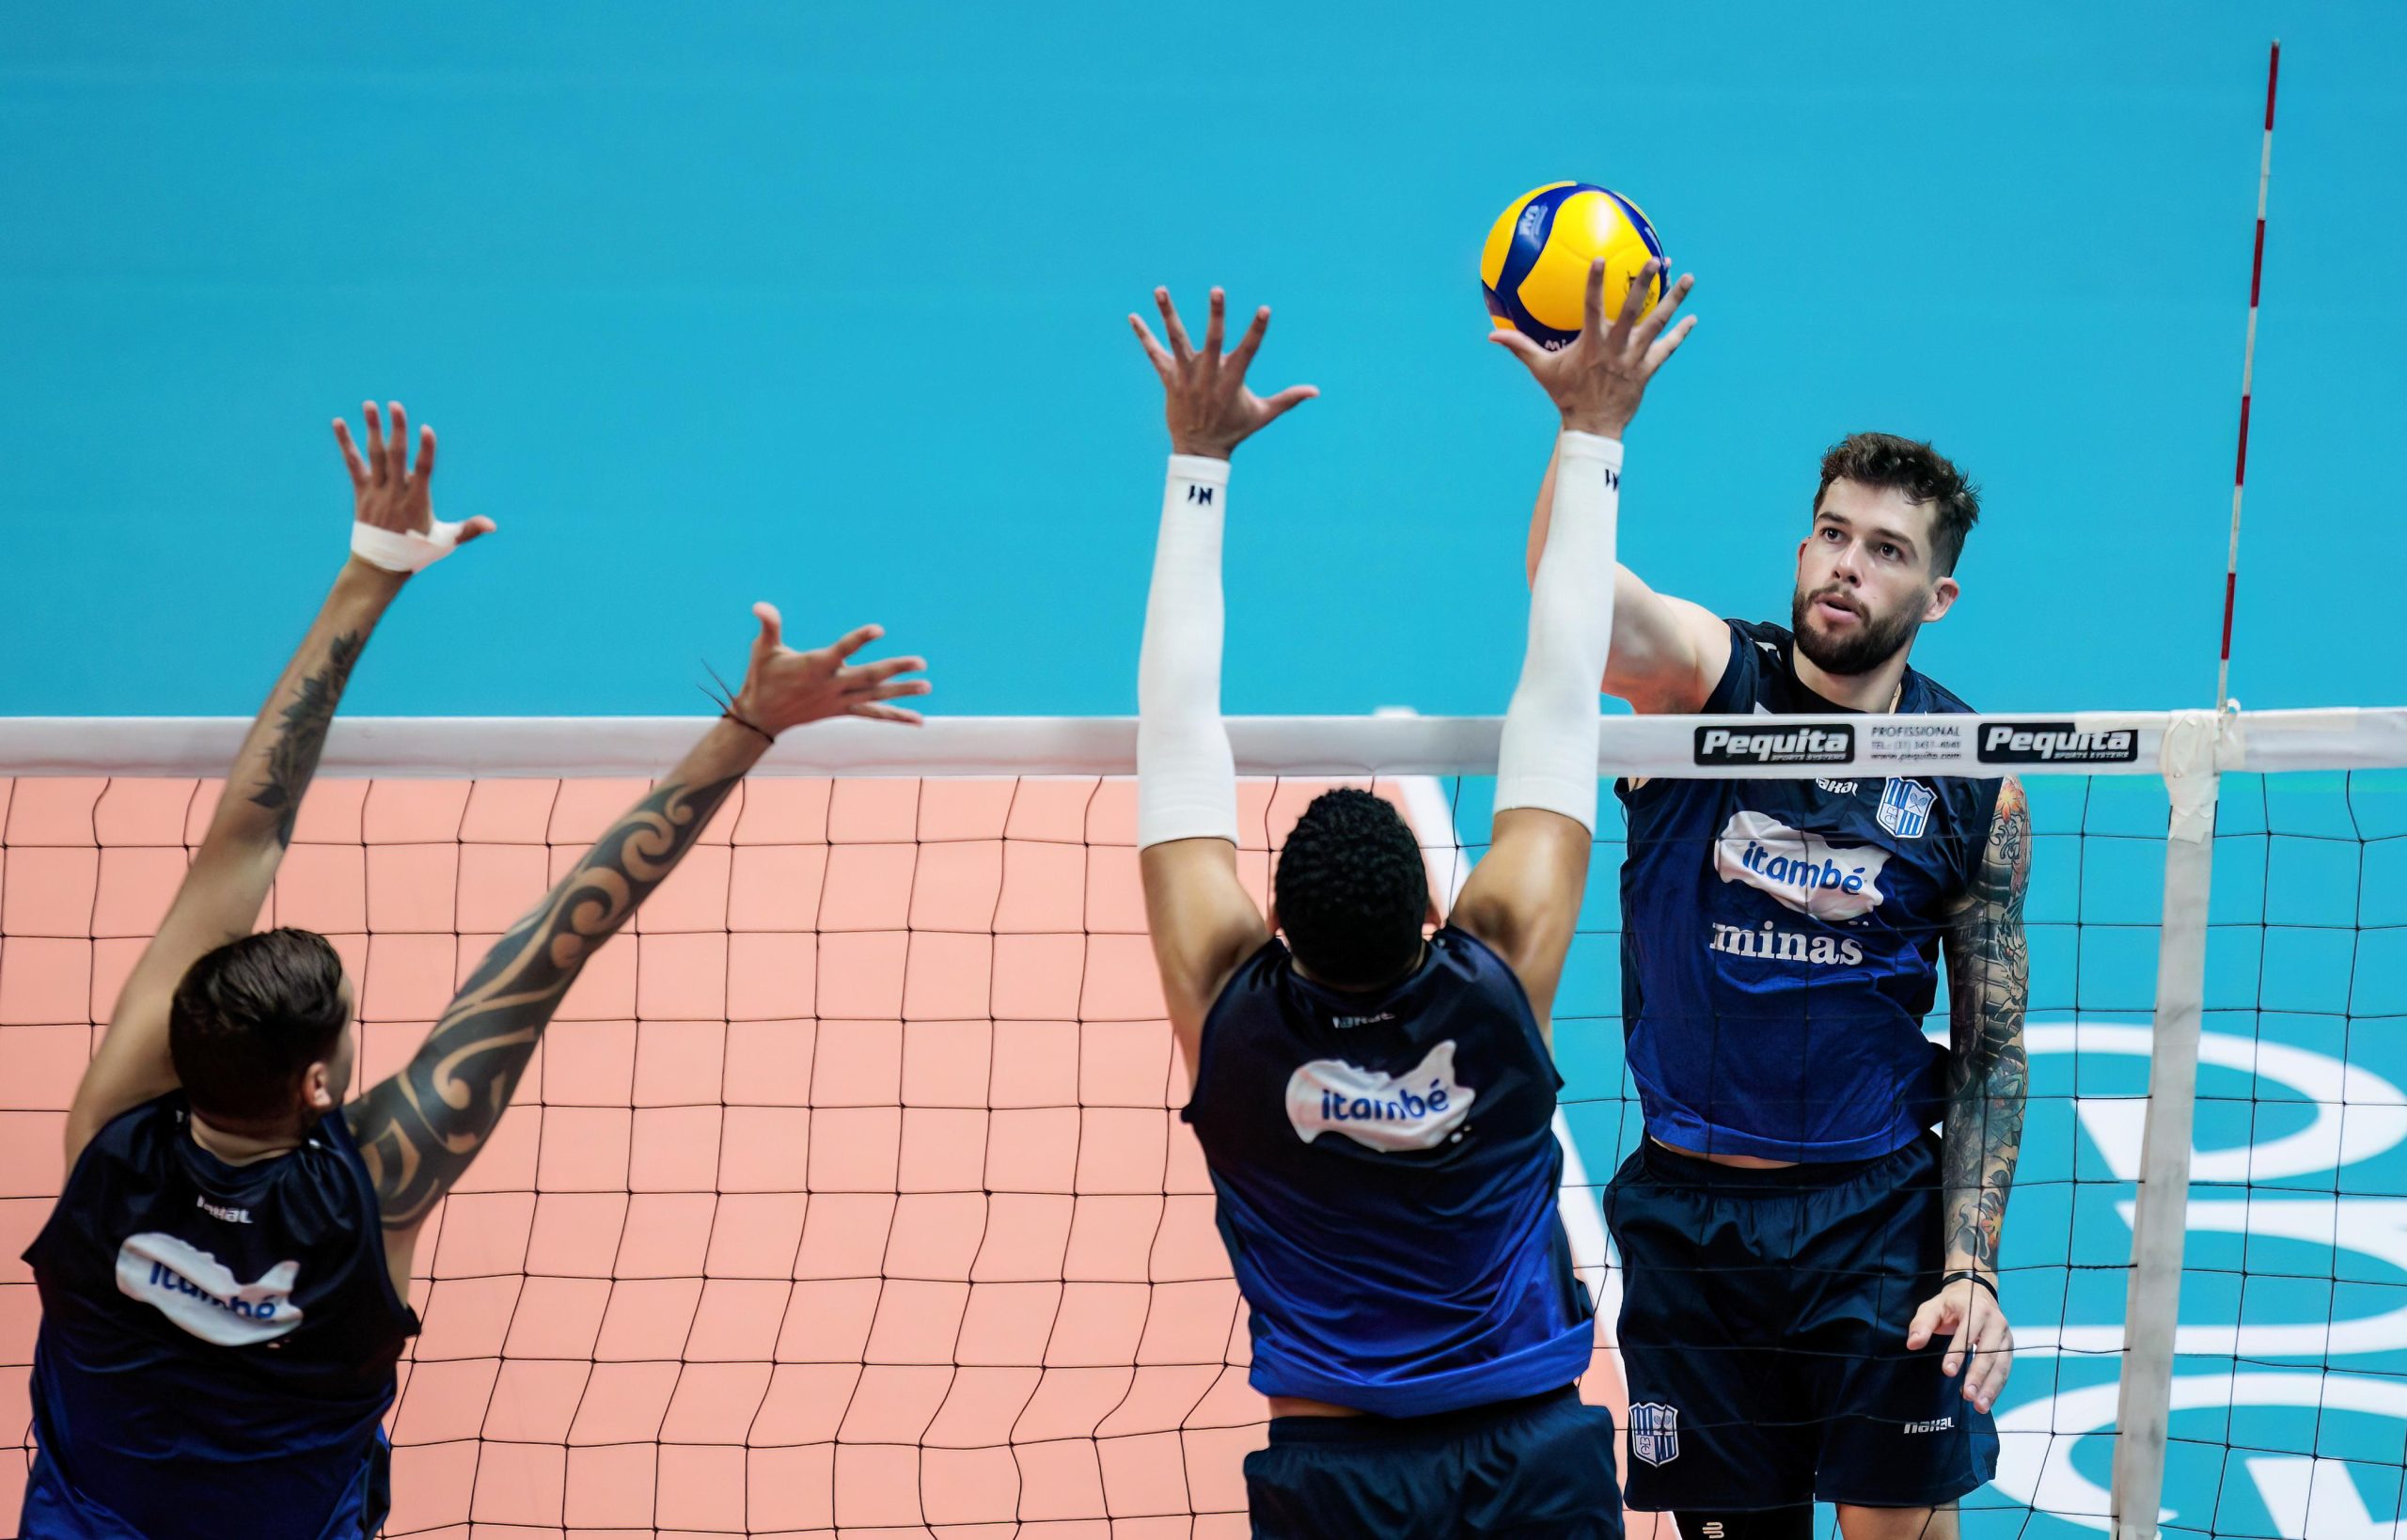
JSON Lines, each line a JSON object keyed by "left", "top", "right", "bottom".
{"left": 2111, "top": 713, "right": 2229, "bottom": 1540}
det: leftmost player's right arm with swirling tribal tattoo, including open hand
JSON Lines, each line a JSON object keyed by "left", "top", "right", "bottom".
{"left": 344, "top": 604, "right": 927, "bottom": 1292}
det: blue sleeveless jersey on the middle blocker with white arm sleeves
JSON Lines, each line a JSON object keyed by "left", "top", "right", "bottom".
{"left": 1185, "top": 926, "right": 1591, "bottom": 1417}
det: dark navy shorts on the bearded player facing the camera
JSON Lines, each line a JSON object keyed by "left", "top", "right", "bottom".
{"left": 1606, "top": 1133, "right": 1998, "bottom": 1511}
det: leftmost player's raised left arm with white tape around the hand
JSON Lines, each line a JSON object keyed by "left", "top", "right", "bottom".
{"left": 68, "top": 401, "right": 494, "bottom": 1167}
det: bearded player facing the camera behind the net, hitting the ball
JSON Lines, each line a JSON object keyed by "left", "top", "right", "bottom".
{"left": 1523, "top": 411, "right": 2032, "bottom": 1540}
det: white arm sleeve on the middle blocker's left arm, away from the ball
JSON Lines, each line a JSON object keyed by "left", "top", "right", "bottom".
{"left": 1136, "top": 455, "right": 1241, "bottom": 849}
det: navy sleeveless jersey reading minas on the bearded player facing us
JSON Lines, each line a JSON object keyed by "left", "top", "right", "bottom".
{"left": 1620, "top": 621, "right": 1998, "bottom": 1160}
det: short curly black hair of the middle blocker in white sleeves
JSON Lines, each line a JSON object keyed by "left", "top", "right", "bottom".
{"left": 1271, "top": 787, "right": 1430, "bottom": 989}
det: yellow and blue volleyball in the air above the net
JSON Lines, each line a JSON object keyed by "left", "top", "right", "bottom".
{"left": 1480, "top": 183, "right": 1663, "bottom": 349}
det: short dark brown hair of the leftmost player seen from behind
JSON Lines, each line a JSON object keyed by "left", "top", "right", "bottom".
{"left": 166, "top": 929, "right": 352, "bottom": 1124}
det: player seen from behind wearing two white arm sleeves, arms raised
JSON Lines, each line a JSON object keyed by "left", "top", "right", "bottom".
{"left": 1129, "top": 267, "right": 1690, "bottom": 1540}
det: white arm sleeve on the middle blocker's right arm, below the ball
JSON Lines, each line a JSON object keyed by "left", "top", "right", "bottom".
{"left": 1495, "top": 431, "right": 1622, "bottom": 833}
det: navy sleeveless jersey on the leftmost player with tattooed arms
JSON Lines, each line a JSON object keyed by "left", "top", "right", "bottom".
{"left": 24, "top": 1092, "right": 418, "bottom": 1540}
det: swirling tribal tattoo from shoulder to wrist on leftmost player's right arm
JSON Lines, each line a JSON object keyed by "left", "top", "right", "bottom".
{"left": 347, "top": 778, "right": 741, "bottom": 1230}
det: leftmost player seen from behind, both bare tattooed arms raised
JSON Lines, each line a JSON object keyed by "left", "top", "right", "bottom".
{"left": 19, "top": 404, "right": 927, "bottom": 1540}
